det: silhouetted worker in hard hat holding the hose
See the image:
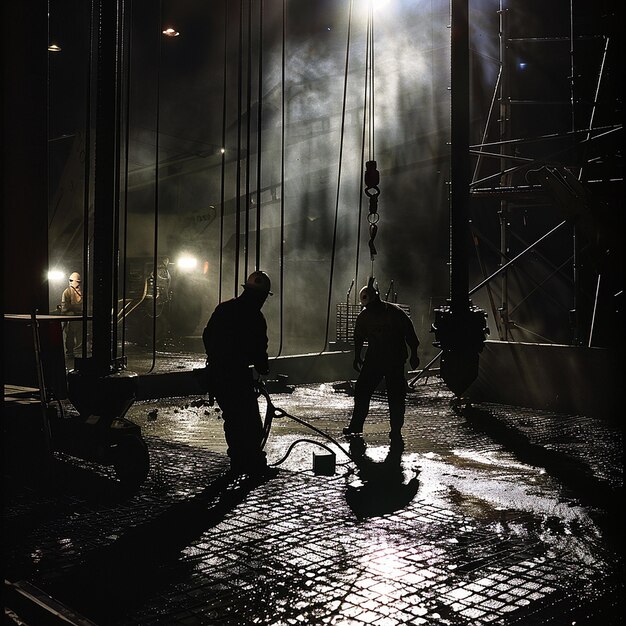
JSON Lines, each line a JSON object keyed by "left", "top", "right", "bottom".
{"left": 202, "top": 271, "right": 275, "bottom": 478}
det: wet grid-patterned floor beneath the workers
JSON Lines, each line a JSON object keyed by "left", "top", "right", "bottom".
{"left": 4, "top": 381, "right": 623, "bottom": 626}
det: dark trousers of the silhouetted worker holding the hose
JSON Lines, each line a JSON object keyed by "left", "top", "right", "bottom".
{"left": 211, "top": 368, "right": 267, "bottom": 472}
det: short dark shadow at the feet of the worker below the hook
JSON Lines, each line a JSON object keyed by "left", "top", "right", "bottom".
{"left": 346, "top": 436, "right": 419, "bottom": 519}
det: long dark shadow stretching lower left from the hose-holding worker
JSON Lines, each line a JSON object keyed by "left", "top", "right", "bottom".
{"left": 47, "top": 473, "right": 265, "bottom": 624}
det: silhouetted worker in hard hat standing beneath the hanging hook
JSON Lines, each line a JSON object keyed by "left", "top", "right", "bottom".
{"left": 343, "top": 278, "right": 420, "bottom": 439}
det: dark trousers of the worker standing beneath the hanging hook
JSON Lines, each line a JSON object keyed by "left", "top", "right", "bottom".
{"left": 349, "top": 357, "right": 407, "bottom": 434}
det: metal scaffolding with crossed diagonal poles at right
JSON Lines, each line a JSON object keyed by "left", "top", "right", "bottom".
{"left": 470, "top": 0, "right": 622, "bottom": 346}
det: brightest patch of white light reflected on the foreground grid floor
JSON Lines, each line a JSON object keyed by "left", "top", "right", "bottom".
{"left": 340, "top": 516, "right": 593, "bottom": 625}
